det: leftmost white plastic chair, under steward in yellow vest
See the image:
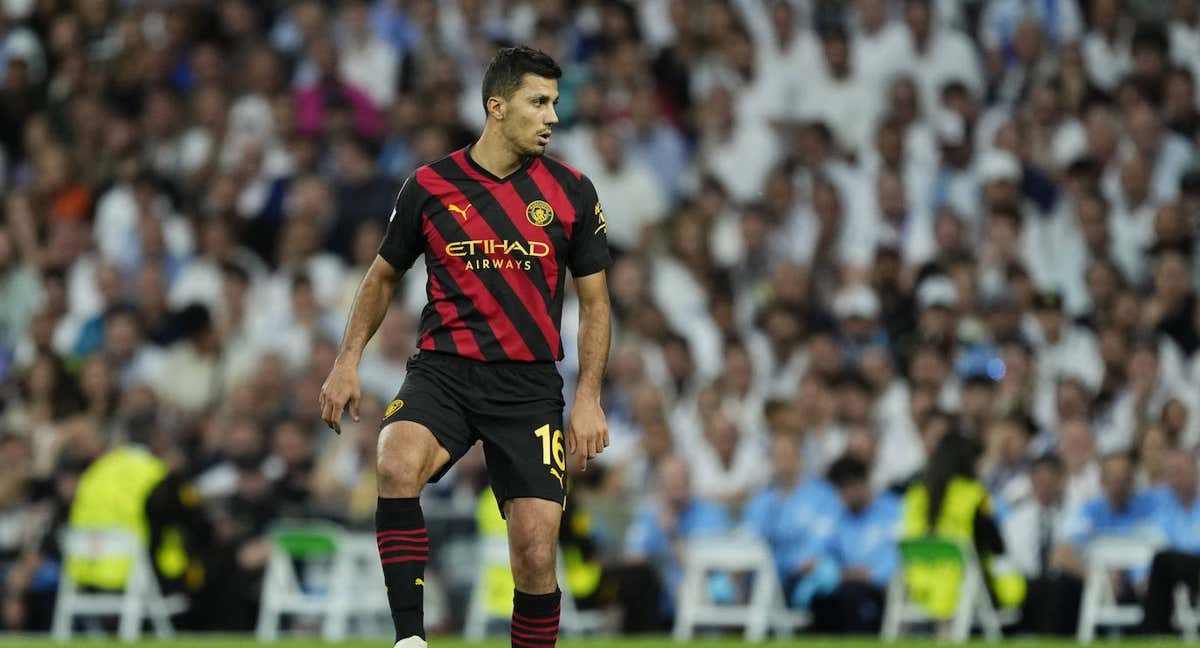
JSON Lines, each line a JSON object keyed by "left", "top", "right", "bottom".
{"left": 50, "top": 528, "right": 187, "bottom": 642}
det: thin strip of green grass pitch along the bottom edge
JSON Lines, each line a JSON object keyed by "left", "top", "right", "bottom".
{"left": 0, "top": 635, "right": 1184, "bottom": 648}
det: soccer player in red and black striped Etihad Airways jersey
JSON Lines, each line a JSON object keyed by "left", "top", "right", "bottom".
{"left": 320, "top": 47, "right": 611, "bottom": 648}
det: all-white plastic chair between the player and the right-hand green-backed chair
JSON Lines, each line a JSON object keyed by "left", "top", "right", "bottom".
{"left": 673, "top": 534, "right": 809, "bottom": 642}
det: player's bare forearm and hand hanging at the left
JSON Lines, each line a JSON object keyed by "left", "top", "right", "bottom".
{"left": 320, "top": 257, "right": 400, "bottom": 434}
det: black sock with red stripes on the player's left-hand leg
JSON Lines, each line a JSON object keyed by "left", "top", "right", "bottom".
{"left": 376, "top": 497, "right": 430, "bottom": 641}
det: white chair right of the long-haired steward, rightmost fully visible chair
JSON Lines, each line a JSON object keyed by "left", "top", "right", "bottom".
{"left": 1075, "top": 535, "right": 1160, "bottom": 643}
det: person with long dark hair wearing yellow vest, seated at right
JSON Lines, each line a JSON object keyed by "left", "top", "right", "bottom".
{"left": 901, "top": 432, "right": 1025, "bottom": 619}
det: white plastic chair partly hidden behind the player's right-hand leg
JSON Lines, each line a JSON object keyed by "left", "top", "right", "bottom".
{"left": 462, "top": 536, "right": 610, "bottom": 642}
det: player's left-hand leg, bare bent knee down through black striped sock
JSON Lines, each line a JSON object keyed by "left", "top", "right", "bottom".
{"left": 376, "top": 420, "right": 450, "bottom": 648}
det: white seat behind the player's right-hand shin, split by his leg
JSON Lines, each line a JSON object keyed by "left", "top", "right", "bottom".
{"left": 463, "top": 536, "right": 610, "bottom": 642}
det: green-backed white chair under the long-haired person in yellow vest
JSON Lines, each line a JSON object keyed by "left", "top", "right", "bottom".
{"left": 881, "top": 538, "right": 1002, "bottom": 643}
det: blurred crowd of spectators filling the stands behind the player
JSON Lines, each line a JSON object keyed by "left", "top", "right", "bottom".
{"left": 0, "top": 0, "right": 1200, "bottom": 628}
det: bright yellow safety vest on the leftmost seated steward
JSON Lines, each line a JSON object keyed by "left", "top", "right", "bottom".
{"left": 66, "top": 448, "right": 187, "bottom": 589}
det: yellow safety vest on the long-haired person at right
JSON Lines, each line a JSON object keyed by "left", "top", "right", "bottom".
{"left": 900, "top": 476, "right": 1025, "bottom": 619}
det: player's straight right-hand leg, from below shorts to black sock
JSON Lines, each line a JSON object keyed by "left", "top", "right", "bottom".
{"left": 504, "top": 497, "right": 563, "bottom": 648}
